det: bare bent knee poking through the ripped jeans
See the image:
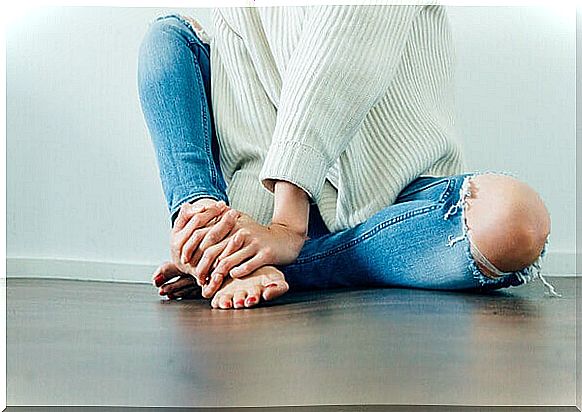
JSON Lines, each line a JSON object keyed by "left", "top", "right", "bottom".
{"left": 466, "top": 174, "right": 551, "bottom": 274}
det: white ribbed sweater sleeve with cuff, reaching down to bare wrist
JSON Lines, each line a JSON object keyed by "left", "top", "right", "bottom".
{"left": 259, "top": 5, "right": 422, "bottom": 201}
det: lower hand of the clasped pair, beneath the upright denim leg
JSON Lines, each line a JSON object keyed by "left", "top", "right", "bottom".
{"left": 170, "top": 199, "right": 238, "bottom": 286}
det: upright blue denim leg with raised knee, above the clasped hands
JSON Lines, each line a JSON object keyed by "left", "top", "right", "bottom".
{"left": 138, "top": 15, "right": 228, "bottom": 224}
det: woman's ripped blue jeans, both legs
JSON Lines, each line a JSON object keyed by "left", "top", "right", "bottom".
{"left": 138, "top": 15, "right": 553, "bottom": 291}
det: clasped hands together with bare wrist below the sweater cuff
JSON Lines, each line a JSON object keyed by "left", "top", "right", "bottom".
{"left": 178, "top": 181, "right": 309, "bottom": 298}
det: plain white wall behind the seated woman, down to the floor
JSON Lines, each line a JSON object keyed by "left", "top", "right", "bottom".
{"left": 7, "top": 7, "right": 575, "bottom": 281}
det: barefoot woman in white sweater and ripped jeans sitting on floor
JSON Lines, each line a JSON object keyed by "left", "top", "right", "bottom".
{"left": 138, "top": 5, "right": 556, "bottom": 309}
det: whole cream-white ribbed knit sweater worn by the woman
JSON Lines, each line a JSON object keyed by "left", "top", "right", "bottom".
{"left": 210, "top": 4, "right": 464, "bottom": 232}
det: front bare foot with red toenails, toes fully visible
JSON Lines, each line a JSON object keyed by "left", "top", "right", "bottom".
{"left": 210, "top": 266, "right": 289, "bottom": 309}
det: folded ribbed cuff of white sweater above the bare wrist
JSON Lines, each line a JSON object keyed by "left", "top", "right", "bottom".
{"left": 259, "top": 141, "right": 329, "bottom": 202}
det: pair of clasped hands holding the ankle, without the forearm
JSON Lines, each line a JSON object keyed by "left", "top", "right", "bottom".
{"left": 154, "top": 201, "right": 307, "bottom": 298}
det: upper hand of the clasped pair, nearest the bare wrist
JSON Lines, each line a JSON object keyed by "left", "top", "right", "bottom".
{"left": 196, "top": 212, "right": 307, "bottom": 298}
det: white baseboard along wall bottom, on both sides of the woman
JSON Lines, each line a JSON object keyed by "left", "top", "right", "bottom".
{"left": 6, "top": 251, "right": 576, "bottom": 284}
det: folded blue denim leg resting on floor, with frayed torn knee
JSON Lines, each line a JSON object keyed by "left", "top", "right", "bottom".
{"left": 280, "top": 172, "right": 559, "bottom": 296}
